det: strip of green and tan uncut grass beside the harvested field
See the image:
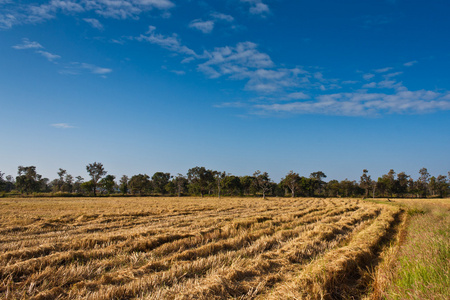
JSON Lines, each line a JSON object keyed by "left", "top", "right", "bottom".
{"left": 372, "top": 199, "right": 450, "bottom": 299}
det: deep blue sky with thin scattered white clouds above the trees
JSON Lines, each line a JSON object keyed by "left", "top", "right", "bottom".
{"left": 0, "top": 0, "right": 450, "bottom": 181}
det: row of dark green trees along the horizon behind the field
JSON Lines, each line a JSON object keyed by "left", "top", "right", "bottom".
{"left": 0, "top": 162, "right": 450, "bottom": 198}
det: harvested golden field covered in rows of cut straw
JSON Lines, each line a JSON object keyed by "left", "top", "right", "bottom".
{"left": 0, "top": 198, "right": 404, "bottom": 299}
